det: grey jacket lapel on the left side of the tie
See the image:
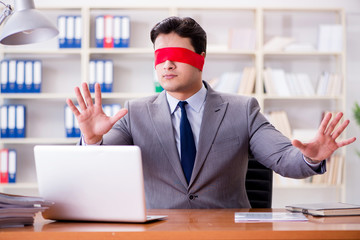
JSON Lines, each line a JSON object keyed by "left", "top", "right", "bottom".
{"left": 148, "top": 91, "right": 188, "bottom": 188}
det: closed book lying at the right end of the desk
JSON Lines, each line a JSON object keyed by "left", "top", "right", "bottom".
{"left": 285, "top": 202, "right": 360, "bottom": 216}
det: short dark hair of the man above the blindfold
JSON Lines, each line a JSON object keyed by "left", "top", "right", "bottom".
{"left": 150, "top": 16, "right": 206, "bottom": 54}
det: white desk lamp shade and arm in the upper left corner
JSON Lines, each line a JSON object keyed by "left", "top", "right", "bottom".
{"left": 0, "top": 0, "right": 59, "bottom": 45}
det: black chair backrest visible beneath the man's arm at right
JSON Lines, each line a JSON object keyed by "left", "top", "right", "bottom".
{"left": 245, "top": 158, "right": 273, "bottom": 208}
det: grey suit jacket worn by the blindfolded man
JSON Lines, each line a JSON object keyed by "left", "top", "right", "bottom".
{"left": 102, "top": 83, "right": 324, "bottom": 208}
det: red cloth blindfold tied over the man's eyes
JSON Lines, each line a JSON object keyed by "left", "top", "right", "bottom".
{"left": 155, "top": 47, "right": 205, "bottom": 71}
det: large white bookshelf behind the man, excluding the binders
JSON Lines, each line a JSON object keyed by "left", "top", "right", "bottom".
{"left": 0, "top": 5, "right": 346, "bottom": 204}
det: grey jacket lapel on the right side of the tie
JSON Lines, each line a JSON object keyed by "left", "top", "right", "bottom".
{"left": 189, "top": 84, "right": 228, "bottom": 187}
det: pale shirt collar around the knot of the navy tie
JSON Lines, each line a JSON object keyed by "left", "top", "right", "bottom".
{"left": 166, "top": 84, "right": 207, "bottom": 114}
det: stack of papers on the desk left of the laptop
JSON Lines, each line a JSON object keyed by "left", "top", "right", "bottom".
{"left": 0, "top": 193, "right": 53, "bottom": 228}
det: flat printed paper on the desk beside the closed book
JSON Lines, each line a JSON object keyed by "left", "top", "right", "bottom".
{"left": 235, "top": 212, "right": 308, "bottom": 222}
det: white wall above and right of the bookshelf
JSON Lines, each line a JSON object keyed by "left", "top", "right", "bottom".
{"left": 31, "top": 0, "right": 360, "bottom": 204}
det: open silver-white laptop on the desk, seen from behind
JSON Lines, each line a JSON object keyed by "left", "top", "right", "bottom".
{"left": 34, "top": 145, "right": 166, "bottom": 222}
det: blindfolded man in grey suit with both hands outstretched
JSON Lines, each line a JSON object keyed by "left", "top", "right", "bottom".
{"left": 67, "top": 17, "right": 355, "bottom": 208}
